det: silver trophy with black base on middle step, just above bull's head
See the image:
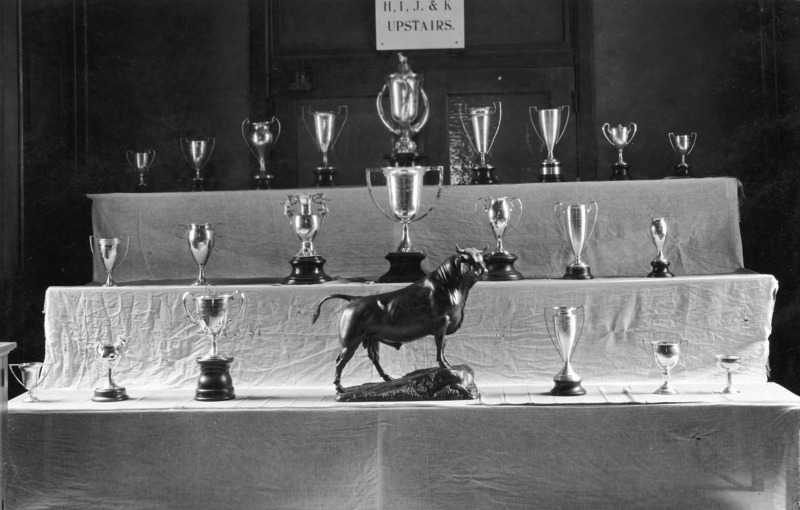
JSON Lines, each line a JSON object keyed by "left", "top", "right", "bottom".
{"left": 475, "top": 197, "right": 523, "bottom": 281}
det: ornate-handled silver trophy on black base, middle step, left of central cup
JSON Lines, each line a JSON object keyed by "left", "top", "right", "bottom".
{"left": 283, "top": 193, "right": 333, "bottom": 285}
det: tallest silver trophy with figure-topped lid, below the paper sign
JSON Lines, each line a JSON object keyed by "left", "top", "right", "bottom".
{"left": 376, "top": 53, "right": 430, "bottom": 166}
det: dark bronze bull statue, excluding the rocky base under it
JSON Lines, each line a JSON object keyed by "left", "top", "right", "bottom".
{"left": 311, "top": 246, "right": 486, "bottom": 393}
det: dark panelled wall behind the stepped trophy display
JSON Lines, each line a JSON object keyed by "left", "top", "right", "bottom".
{"left": 0, "top": 0, "right": 800, "bottom": 395}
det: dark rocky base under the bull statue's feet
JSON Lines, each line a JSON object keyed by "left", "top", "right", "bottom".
{"left": 336, "top": 365, "right": 480, "bottom": 402}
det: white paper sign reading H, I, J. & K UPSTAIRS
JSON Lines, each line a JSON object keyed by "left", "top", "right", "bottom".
{"left": 375, "top": 0, "right": 464, "bottom": 50}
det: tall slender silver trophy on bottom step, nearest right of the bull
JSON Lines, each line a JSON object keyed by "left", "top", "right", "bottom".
{"left": 544, "top": 306, "right": 586, "bottom": 397}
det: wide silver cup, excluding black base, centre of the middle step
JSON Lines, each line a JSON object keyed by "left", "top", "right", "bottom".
{"left": 367, "top": 166, "right": 444, "bottom": 253}
